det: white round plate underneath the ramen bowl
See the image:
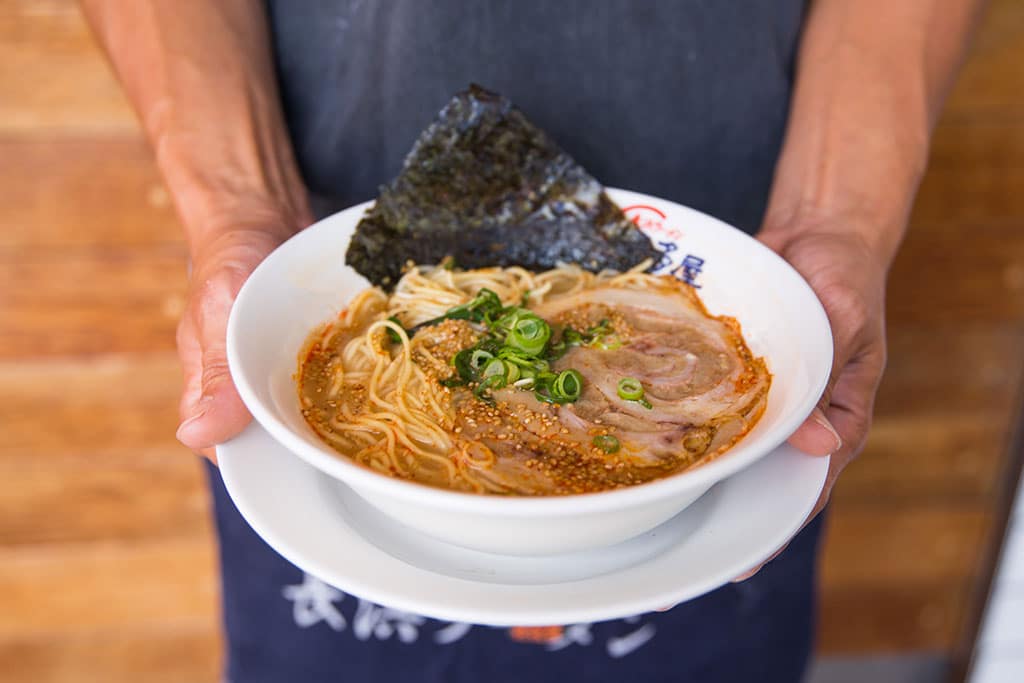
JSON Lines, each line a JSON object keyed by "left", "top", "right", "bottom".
{"left": 217, "top": 422, "right": 828, "bottom": 626}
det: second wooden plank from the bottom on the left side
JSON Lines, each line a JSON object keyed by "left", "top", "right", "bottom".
{"left": 0, "top": 539, "right": 218, "bottom": 642}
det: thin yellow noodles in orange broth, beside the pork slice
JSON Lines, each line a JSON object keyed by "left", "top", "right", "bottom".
{"left": 300, "top": 262, "right": 760, "bottom": 494}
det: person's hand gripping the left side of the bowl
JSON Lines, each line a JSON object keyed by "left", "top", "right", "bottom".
{"left": 177, "top": 217, "right": 308, "bottom": 461}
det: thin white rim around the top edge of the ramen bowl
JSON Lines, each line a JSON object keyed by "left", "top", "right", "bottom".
{"left": 226, "top": 187, "right": 835, "bottom": 517}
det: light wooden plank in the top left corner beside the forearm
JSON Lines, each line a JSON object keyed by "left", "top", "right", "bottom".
{"left": 0, "top": 0, "right": 139, "bottom": 136}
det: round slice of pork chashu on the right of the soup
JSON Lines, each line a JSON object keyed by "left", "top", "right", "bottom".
{"left": 535, "top": 278, "right": 771, "bottom": 461}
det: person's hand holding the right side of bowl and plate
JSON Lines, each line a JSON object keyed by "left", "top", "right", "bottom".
{"left": 734, "top": 224, "right": 888, "bottom": 581}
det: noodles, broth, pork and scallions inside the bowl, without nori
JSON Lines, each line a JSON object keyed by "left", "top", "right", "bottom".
{"left": 298, "top": 263, "right": 771, "bottom": 496}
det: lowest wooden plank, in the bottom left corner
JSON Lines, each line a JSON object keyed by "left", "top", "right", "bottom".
{"left": 0, "top": 624, "right": 221, "bottom": 683}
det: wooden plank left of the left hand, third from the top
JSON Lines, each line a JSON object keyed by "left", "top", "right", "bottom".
{"left": 0, "top": 246, "right": 187, "bottom": 359}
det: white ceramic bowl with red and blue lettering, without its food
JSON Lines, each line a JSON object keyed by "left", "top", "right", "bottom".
{"left": 227, "top": 189, "right": 833, "bottom": 555}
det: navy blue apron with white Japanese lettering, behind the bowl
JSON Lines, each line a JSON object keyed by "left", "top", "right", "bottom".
{"left": 210, "top": 0, "right": 820, "bottom": 683}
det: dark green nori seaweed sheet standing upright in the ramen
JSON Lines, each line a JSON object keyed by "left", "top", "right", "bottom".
{"left": 346, "top": 85, "right": 659, "bottom": 289}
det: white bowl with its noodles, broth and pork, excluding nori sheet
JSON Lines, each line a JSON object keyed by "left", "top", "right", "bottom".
{"left": 227, "top": 189, "right": 831, "bottom": 555}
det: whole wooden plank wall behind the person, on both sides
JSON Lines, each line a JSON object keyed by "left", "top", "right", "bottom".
{"left": 0, "top": 0, "right": 1024, "bottom": 683}
